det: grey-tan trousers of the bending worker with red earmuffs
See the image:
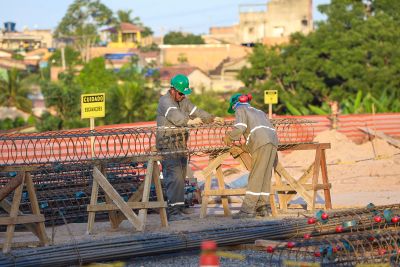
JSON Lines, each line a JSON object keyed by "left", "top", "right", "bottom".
{"left": 241, "top": 144, "right": 277, "bottom": 213}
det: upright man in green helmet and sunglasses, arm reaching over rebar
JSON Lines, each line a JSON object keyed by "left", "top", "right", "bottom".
{"left": 157, "top": 74, "right": 224, "bottom": 221}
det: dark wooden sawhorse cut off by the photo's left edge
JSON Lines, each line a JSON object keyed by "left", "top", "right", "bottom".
{"left": 0, "top": 167, "right": 49, "bottom": 253}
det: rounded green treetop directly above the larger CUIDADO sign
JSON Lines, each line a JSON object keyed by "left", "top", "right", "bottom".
{"left": 76, "top": 57, "right": 117, "bottom": 93}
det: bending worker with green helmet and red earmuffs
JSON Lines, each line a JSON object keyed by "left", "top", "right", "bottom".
{"left": 224, "top": 93, "right": 278, "bottom": 219}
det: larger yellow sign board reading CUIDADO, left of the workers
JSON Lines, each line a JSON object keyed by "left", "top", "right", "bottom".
{"left": 81, "top": 93, "right": 106, "bottom": 119}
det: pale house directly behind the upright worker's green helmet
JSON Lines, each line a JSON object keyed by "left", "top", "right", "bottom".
{"left": 159, "top": 65, "right": 211, "bottom": 93}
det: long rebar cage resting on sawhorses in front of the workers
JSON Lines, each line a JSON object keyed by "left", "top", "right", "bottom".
{"left": 0, "top": 119, "right": 314, "bottom": 166}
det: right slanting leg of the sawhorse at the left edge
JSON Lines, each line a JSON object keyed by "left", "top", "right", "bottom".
{"left": 25, "top": 172, "right": 49, "bottom": 246}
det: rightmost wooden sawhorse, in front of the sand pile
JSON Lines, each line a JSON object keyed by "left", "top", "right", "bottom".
{"left": 272, "top": 143, "right": 332, "bottom": 215}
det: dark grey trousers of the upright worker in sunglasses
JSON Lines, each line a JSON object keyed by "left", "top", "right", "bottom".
{"left": 161, "top": 155, "right": 187, "bottom": 214}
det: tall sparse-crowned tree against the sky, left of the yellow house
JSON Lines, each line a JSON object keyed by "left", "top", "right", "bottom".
{"left": 54, "top": 0, "right": 115, "bottom": 62}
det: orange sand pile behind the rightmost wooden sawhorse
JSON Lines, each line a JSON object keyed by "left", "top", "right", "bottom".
{"left": 280, "top": 130, "right": 400, "bottom": 207}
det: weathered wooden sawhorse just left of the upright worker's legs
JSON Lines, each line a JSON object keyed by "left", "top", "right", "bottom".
{"left": 87, "top": 157, "right": 168, "bottom": 234}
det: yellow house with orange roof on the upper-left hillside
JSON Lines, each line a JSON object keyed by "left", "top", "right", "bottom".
{"left": 101, "top": 23, "right": 143, "bottom": 48}
